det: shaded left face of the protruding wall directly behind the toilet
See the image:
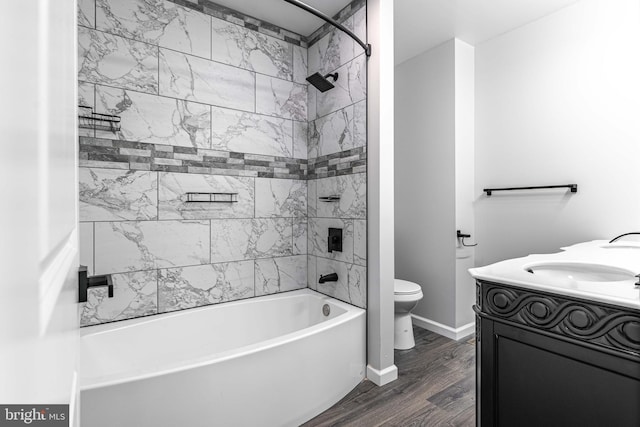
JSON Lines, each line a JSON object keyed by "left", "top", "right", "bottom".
{"left": 395, "top": 40, "right": 456, "bottom": 326}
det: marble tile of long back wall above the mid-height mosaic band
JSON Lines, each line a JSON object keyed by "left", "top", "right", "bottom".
{"left": 78, "top": 0, "right": 307, "bottom": 159}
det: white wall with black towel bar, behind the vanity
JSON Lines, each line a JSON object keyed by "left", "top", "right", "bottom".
{"left": 475, "top": 0, "right": 640, "bottom": 265}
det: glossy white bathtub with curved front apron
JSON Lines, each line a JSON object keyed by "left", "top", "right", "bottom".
{"left": 80, "top": 289, "right": 366, "bottom": 427}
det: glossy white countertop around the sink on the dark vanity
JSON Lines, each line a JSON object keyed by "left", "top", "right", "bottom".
{"left": 469, "top": 240, "right": 640, "bottom": 310}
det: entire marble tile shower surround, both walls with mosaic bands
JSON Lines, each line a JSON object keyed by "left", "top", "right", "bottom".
{"left": 79, "top": 0, "right": 366, "bottom": 325}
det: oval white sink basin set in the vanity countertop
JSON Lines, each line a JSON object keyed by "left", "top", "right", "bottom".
{"left": 525, "top": 262, "right": 635, "bottom": 282}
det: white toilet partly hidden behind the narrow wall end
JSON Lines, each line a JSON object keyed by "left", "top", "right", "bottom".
{"left": 393, "top": 279, "right": 422, "bottom": 350}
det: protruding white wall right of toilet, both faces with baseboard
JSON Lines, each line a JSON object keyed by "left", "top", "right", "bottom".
{"left": 395, "top": 39, "right": 475, "bottom": 338}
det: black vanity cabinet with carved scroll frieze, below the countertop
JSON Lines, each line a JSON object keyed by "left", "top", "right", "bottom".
{"left": 474, "top": 280, "right": 640, "bottom": 427}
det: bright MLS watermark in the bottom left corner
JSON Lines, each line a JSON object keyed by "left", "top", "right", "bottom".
{"left": 0, "top": 405, "right": 69, "bottom": 427}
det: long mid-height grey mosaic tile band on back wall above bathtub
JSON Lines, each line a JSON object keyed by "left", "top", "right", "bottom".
{"left": 80, "top": 137, "right": 307, "bottom": 180}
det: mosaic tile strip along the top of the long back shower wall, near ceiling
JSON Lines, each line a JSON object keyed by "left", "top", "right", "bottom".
{"left": 169, "top": 0, "right": 307, "bottom": 47}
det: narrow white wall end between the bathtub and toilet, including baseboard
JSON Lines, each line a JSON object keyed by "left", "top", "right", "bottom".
{"left": 367, "top": 0, "right": 398, "bottom": 385}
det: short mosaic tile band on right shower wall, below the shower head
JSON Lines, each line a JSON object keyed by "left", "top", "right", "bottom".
{"left": 306, "top": 147, "right": 367, "bottom": 179}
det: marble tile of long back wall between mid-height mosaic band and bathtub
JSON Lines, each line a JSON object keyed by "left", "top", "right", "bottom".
{"left": 79, "top": 167, "right": 307, "bottom": 326}
